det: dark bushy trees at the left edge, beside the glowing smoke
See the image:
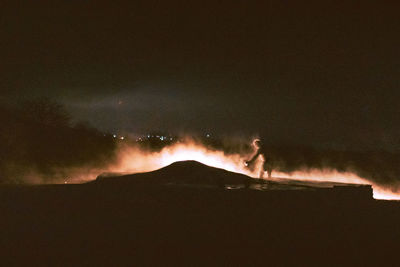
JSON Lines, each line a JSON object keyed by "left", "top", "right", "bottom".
{"left": 0, "top": 99, "right": 116, "bottom": 183}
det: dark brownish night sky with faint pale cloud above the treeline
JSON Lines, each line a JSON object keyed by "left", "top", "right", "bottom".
{"left": 0, "top": 0, "right": 400, "bottom": 149}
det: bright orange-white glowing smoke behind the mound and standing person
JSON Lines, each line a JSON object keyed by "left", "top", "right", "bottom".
{"left": 102, "top": 141, "right": 400, "bottom": 200}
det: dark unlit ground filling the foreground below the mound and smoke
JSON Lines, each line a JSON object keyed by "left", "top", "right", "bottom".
{"left": 0, "top": 163, "right": 400, "bottom": 266}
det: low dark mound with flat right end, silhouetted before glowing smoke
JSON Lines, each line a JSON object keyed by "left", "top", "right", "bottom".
{"left": 90, "top": 161, "right": 372, "bottom": 201}
